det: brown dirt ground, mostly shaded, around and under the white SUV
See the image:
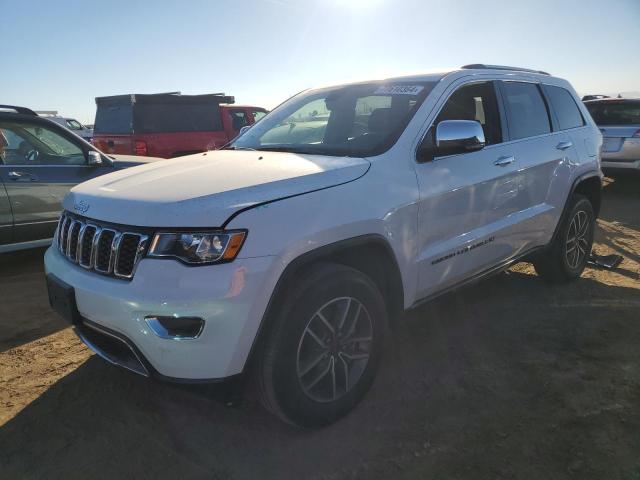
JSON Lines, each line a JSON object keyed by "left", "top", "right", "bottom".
{"left": 0, "top": 179, "right": 640, "bottom": 480}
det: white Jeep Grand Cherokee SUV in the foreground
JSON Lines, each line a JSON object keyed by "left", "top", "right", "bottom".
{"left": 46, "top": 65, "right": 602, "bottom": 427}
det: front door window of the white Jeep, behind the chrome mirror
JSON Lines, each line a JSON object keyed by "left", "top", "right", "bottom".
{"left": 436, "top": 82, "right": 502, "bottom": 145}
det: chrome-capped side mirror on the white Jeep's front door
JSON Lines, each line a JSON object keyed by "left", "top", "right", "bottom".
{"left": 434, "top": 120, "right": 485, "bottom": 156}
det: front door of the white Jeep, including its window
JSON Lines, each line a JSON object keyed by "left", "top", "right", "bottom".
{"left": 416, "top": 81, "right": 519, "bottom": 297}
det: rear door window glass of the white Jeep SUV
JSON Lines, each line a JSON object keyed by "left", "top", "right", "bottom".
{"left": 502, "top": 82, "right": 551, "bottom": 140}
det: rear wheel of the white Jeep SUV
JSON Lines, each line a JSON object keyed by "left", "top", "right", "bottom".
{"left": 533, "top": 194, "right": 596, "bottom": 283}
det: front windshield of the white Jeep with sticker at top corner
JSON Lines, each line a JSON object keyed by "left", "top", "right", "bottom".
{"left": 229, "top": 82, "right": 435, "bottom": 156}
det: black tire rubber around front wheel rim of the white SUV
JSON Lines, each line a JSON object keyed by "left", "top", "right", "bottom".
{"left": 271, "top": 265, "right": 387, "bottom": 427}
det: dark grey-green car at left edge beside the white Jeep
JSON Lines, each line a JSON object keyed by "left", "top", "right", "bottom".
{"left": 0, "top": 105, "right": 158, "bottom": 252}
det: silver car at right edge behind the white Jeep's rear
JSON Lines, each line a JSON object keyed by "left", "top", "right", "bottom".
{"left": 585, "top": 98, "right": 640, "bottom": 171}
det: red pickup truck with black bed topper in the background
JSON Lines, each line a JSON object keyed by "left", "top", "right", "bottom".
{"left": 93, "top": 92, "right": 267, "bottom": 158}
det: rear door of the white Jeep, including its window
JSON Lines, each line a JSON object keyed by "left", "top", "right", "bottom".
{"left": 499, "top": 81, "right": 578, "bottom": 249}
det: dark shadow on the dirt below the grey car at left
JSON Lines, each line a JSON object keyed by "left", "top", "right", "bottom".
{"left": 0, "top": 248, "right": 69, "bottom": 352}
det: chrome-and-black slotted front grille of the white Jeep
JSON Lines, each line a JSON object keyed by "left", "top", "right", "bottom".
{"left": 56, "top": 212, "right": 149, "bottom": 279}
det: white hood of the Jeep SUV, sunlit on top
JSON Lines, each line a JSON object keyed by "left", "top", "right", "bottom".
{"left": 63, "top": 150, "right": 370, "bottom": 227}
